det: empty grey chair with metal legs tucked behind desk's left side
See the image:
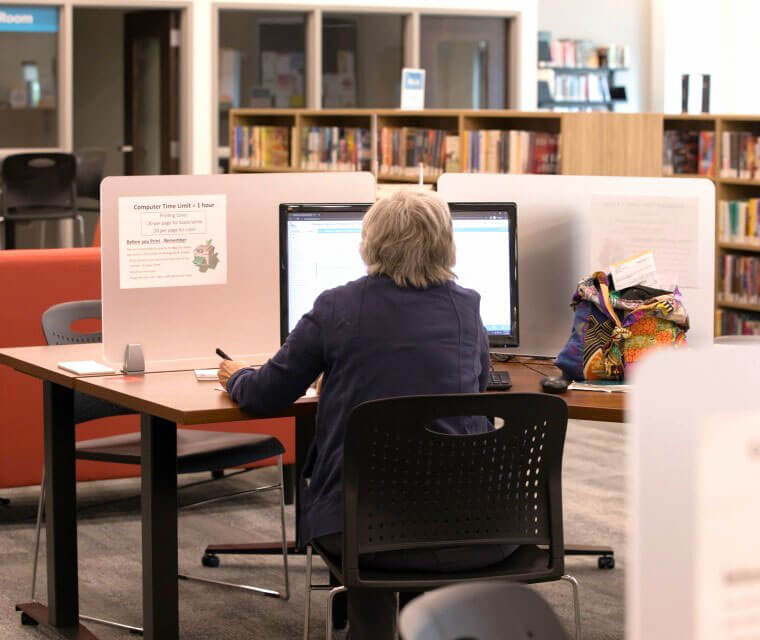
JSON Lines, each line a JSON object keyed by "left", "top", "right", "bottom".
{"left": 31, "top": 300, "right": 290, "bottom": 632}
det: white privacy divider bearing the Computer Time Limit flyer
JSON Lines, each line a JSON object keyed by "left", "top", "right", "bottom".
{"left": 101, "top": 172, "right": 375, "bottom": 371}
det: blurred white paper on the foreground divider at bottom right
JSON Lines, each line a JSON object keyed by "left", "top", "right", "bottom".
{"left": 693, "top": 410, "right": 760, "bottom": 640}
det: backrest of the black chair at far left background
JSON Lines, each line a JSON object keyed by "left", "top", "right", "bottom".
{"left": 2, "top": 153, "right": 76, "bottom": 214}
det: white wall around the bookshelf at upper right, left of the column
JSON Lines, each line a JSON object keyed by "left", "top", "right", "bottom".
{"left": 538, "top": 0, "right": 652, "bottom": 112}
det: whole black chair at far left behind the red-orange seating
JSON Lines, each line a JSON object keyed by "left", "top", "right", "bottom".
{"left": 0, "top": 153, "right": 85, "bottom": 249}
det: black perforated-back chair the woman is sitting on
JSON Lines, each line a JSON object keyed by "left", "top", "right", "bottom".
{"left": 304, "top": 393, "right": 581, "bottom": 640}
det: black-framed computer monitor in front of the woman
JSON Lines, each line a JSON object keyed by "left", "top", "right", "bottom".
{"left": 280, "top": 202, "right": 519, "bottom": 348}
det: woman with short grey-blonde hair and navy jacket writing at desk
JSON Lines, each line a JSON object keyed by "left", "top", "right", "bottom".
{"left": 219, "top": 191, "right": 513, "bottom": 640}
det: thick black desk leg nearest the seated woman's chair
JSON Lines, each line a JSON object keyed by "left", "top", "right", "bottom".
{"left": 141, "top": 415, "right": 179, "bottom": 640}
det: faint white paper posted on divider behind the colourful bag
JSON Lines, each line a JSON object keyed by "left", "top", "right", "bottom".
{"left": 591, "top": 194, "right": 700, "bottom": 288}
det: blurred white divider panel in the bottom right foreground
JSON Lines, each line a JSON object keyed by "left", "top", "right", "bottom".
{"left": 625, "top": 344, "right": 760, "bottom": 640}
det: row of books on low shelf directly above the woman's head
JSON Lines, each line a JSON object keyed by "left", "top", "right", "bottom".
{"left": 378, "top": 127, "right": 459, "bottom": 179}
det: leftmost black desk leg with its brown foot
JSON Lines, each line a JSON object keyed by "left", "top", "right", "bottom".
{"left": 16, "top": 382, "right": 102, "bottom": 640}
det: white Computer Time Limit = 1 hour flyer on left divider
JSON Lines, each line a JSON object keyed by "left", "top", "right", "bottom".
{"left": 119, "top": 194, "right": 229, "bottom": 289}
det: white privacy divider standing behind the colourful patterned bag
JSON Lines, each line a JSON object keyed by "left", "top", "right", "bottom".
{"left": 438, "top": 173, "right": 715, "bottom": 356}
